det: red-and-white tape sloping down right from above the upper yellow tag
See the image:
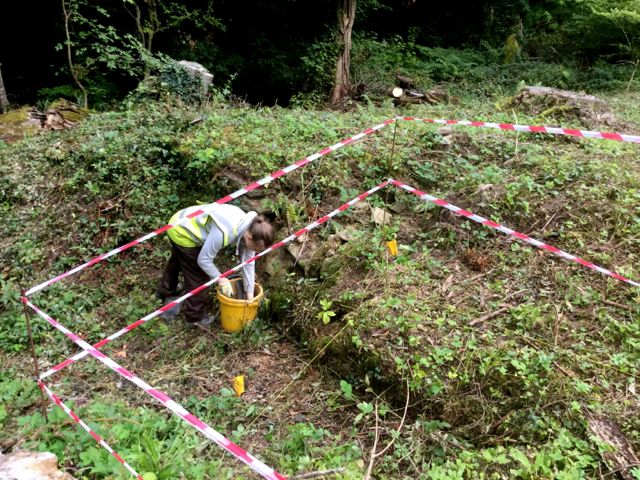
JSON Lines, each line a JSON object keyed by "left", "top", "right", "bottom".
{"left": 389, "top": 179, "right": 640, "bottom": 287}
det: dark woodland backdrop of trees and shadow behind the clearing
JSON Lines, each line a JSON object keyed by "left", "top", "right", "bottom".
{"left": 0, "top": 0, "right": 640, "bottom": 109}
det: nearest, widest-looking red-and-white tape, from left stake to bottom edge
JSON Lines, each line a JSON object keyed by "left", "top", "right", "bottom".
{"left": 22, "top": 297, "right": 286, "bottom": 480}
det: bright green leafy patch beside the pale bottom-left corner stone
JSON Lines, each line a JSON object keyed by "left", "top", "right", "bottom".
{"left": 11, "top": 394, "right": 229, "bottom": 480}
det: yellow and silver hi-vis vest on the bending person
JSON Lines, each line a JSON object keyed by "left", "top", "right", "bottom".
{"left": 167, "top": 205, "right": 242, "bottom": 247}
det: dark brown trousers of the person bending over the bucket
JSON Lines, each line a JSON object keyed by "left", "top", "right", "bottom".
{"left": 158, "top": 242, "right": 210, "bottom": 322}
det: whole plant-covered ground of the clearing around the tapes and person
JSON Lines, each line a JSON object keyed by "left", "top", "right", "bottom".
{"left": 0, "top": 93, "right": 640, "bottom": 479}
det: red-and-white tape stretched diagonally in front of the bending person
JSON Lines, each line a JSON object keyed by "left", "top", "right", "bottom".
{"left": 40, "top": 180, "right": 390, "bottom": 379}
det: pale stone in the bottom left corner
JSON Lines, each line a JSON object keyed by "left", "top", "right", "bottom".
{"left": 0, "top": 450, "right": 74, "bottom": 480}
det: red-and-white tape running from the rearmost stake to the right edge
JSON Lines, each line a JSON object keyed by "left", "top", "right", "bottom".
{"left": 395, "top": 117, "right": 640, "bottom": 143}
